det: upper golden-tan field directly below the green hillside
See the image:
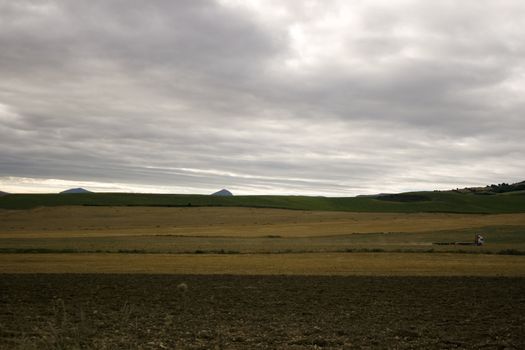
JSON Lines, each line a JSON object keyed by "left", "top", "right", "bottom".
{"left": 0, "top": 207, "right": 525, "bottom": 238}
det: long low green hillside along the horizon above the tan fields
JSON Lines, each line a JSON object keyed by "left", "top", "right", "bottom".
{"left": 0, "top": 191, "right": 525, "bottom": 213}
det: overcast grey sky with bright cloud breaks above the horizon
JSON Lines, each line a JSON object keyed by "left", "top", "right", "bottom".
{"left": 0, "top": 0, "right": 525, "bottom": 196}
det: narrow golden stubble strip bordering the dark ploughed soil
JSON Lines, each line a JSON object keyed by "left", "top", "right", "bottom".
{"left": 0, "top": 253, "right": 525, "bottom": 276}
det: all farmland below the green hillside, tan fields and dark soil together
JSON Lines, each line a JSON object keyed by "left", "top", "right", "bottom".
{"left": 0, "top": 202, "right": 525, "bottom": 349}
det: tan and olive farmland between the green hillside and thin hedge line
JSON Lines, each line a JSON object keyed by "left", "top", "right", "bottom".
{"left": 0, "top": 206, "right": 525, "bottom": 253}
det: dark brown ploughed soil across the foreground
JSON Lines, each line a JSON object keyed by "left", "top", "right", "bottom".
{"left": 0, "top": 274, "right": 525, "bottom": 349}
